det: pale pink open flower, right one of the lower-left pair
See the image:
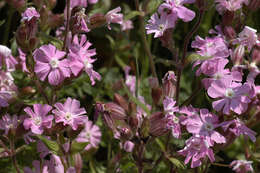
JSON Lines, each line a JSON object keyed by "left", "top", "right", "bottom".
{"left": 52, "top": 97, "right": 86, "bottom": 130}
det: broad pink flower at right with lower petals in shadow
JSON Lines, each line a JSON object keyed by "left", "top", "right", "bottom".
{"left": 208, "top": 80, "right": 251, "bottom": 114}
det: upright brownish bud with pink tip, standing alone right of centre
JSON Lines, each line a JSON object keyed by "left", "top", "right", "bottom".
{"left": 162, "top": 71, "right": 176, "bottom": 98}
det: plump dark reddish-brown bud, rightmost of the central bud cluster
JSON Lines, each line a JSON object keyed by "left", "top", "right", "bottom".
{"left": 149, "top": 112, "right": 168, "bottom": 136}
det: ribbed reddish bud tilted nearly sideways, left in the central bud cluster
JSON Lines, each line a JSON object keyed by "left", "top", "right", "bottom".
{"left": 105, "top": 102, "right": 127, "bottom": 120}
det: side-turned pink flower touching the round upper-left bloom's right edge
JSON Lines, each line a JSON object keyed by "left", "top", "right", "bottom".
{"left": 69, "top": 35, "right": 101, "bottom": 85}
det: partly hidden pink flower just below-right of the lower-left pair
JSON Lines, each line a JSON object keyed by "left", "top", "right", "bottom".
{"left": 76, "top": 120, "right": 101, "bottom": 150}
